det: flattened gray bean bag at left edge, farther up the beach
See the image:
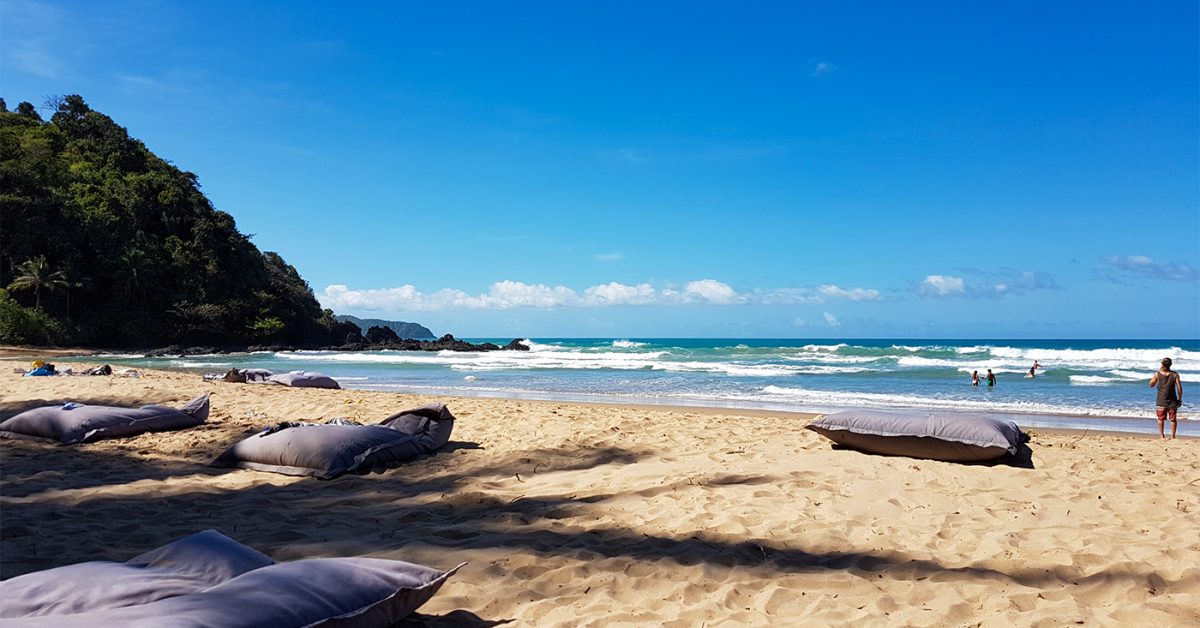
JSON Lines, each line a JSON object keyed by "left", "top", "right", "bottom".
{"left": 0, "top": 395, "right": 209, "bottom": 444}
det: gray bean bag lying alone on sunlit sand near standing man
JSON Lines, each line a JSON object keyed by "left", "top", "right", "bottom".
{"left": 806, "top": 409, "right": 1025, "bottom": 462}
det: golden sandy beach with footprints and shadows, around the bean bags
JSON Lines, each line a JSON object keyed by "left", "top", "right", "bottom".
{"left": 0, "top": 359, "right": 1200, "bottom": 626}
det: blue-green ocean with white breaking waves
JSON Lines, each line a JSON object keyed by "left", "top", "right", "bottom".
{"left": 79, "top": 339, "right": 1200, "bottom": 435}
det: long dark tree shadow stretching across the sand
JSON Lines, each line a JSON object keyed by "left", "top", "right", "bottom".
{"left": 0, "top": 427, "right": 1185, "bottom": 626}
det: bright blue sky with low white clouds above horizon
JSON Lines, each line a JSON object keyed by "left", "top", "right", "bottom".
{"left": 0, "top": 0, "right": 1200, "bottom": 339}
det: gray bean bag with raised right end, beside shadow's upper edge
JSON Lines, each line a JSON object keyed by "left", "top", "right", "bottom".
{"left": 212, "top": 403, "right": 455, "bottom": 479}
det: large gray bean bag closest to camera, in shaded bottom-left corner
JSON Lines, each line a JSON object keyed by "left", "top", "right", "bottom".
{"left": 0, "top": 530, "right": 462, "bottom": 628}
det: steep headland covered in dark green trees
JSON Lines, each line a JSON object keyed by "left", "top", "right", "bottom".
{"left": 0, "top": 96, "right": 359, "bottom": 347}
